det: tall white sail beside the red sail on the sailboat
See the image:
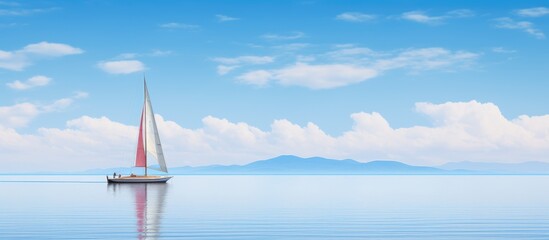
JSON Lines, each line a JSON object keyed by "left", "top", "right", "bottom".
{"left": 144, "top": 84, "right": 168, "bottom": 172}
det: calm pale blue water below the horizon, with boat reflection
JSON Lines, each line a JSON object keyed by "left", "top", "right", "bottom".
{"left": 0, "top": 176, "right": 549, "bottom": 239}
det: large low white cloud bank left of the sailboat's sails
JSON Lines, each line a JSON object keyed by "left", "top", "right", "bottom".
{"left": 0, "top": 116, "right": 137, "bottom": 171}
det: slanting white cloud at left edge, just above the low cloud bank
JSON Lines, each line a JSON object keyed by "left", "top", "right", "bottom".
{"left": 0, "top": 92, "right": 88, "bottom": 128}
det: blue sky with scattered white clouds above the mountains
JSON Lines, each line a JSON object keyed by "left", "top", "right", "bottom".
{"left": 0, "top": 0, "right": 549, "bottom": 172}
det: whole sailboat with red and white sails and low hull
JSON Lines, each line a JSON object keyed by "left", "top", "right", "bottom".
{"left": 107, "top": 79, "right": 172, "bottom": 183}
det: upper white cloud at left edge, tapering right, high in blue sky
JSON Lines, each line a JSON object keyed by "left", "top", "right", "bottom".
{"left": 0, "top": 42, "right": 84, "bottom": 71}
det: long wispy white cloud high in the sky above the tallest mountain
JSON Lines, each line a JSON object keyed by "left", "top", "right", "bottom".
{"left": 230, "top": 46, "right": 479, "bottom": 89}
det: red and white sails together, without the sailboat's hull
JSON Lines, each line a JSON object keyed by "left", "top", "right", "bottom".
{"left": 135, "top": 82, "right": 168, "bottom": 172}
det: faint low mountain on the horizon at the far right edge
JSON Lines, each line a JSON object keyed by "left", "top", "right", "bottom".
{"left": 437, "top": 161, "right": 549, "bottom": 174}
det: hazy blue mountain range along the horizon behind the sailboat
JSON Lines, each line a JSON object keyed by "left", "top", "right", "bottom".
{"left": 75, "top": 155, "right": 549, "bottom": 175}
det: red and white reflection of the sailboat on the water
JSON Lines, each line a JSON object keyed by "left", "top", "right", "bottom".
{"left": 108, "top": 183, "right": 168, "bottom": 239}
